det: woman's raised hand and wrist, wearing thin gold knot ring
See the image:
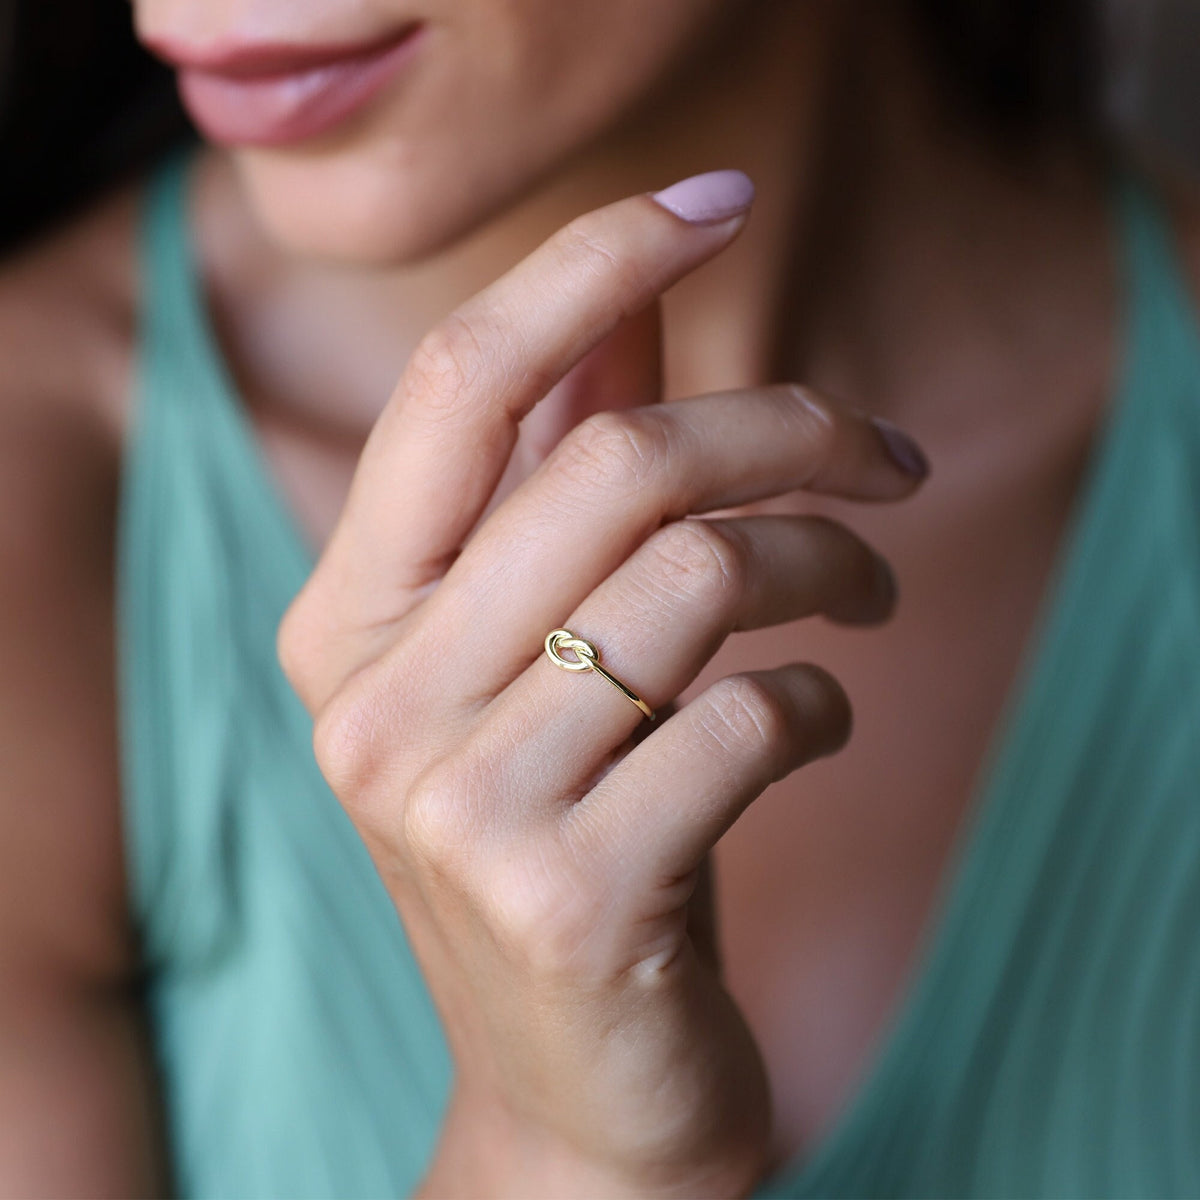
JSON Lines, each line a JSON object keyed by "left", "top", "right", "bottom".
{"left": 280, "top": 177, "right": 920, "bottom": 1196}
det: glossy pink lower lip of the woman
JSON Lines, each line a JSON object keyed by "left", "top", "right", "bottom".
{"left": 179, "top": 26, "right": 422, "bottom": 145}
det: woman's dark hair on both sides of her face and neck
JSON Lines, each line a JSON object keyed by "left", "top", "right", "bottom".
{"left": 0, "top": 0, "right": 1097, "bottom": 260}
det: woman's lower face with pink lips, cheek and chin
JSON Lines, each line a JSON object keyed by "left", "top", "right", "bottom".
{"left": 154, "top": 0, "right": 742, "bottom": 268}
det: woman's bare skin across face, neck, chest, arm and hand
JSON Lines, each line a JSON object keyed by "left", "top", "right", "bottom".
{"left": 0, "top": 0, "right": 1196, "bottom": 1195}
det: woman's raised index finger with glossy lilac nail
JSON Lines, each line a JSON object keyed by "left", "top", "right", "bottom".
{"left": 314, "top": 170, "right": 754, "bottom": 630}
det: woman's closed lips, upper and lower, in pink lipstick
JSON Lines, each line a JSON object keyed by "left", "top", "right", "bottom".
{"left": 146, "top": 24, "right": 424, "bottom": 145}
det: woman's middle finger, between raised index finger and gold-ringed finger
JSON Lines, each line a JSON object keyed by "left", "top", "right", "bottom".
{"left": 419, "top": 384, "right": 923, "bottom": 703}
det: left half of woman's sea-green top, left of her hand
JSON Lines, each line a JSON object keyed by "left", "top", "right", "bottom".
{"left": 118, "top": 148, "right": 452, "bottom": 1196}
